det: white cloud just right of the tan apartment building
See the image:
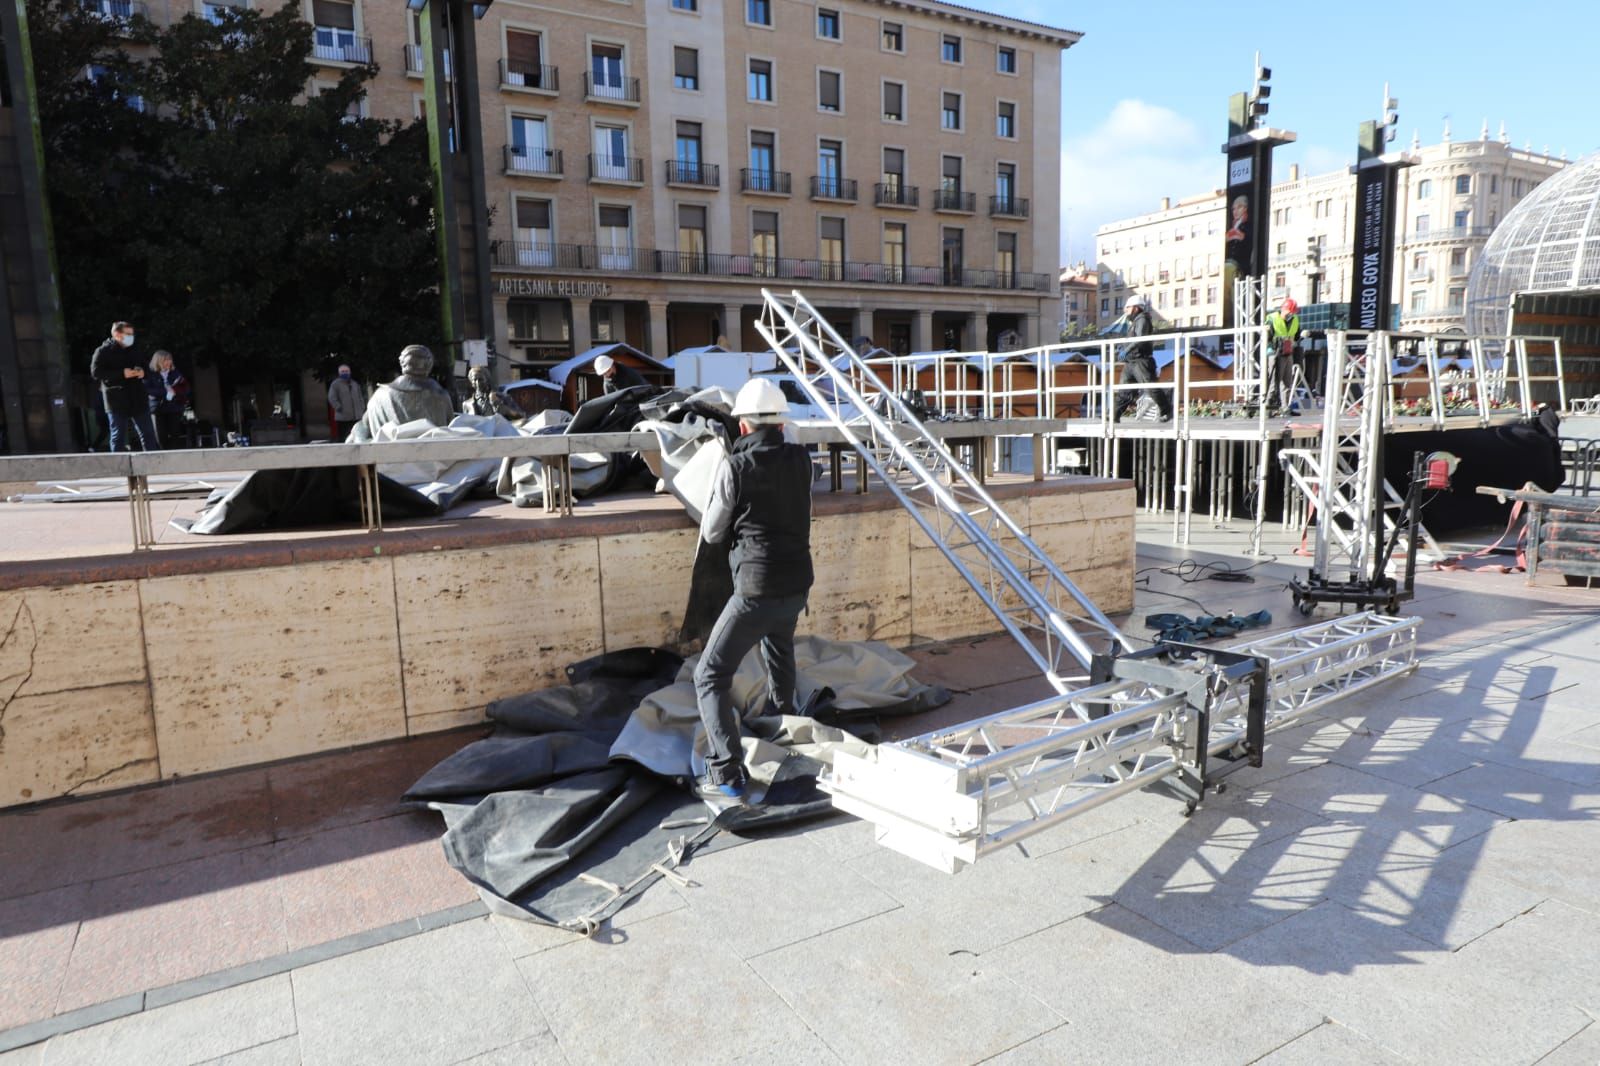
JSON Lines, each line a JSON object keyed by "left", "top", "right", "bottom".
{"left": 1061, "top": 99, "right": 1227, "bottom": 262}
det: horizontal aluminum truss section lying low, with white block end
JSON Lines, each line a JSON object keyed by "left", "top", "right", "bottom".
{"left": 822, "top": 613, "right": 1419, "bottom": 872}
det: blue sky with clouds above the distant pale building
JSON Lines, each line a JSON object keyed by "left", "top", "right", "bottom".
{"left": 992, "top": 0, "right": 1600, "bottom": 262}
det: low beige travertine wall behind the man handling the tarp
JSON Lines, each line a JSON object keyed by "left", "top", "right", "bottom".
{"left": 0, "top": 483, "right": 1134, "bottom": 807}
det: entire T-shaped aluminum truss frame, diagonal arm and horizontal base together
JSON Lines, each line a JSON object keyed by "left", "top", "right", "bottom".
{"left": 757, "top": 290, "right": 1418, "bottom": 872}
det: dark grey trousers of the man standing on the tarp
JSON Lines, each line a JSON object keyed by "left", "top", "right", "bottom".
{"left": 694, "top": 594, "right": 806, "bottom": 784}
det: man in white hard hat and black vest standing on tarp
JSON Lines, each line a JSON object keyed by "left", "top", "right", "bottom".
{"left": 694, "top": 378, "right": 813, "bottom": 802}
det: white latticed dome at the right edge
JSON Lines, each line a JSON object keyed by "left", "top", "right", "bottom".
{"left": 1467, "top": 152, "right": 1600, "bottom": 395}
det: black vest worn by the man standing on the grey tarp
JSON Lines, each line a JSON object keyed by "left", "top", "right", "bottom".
{"left": 728, "top": 426, "right": 814, "bottom": 597}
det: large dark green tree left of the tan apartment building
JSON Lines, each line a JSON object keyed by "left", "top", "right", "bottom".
{"left": 29, "top": 0, "right": 438, "bottom": 393}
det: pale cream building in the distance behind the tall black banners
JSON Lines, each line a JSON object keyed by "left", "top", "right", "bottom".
{"left": 1096, "top": 126, "right": 1565, "bottom": 331}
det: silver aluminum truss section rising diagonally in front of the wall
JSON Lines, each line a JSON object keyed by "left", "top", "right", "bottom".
{"left": 755, "top": 290, "right": 1133, "bottom": 693}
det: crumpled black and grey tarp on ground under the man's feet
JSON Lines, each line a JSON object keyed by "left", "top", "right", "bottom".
{"left": 405, "top": 637, "right": 949, "bottom": 932}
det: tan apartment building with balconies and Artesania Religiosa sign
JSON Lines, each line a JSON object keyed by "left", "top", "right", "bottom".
{"left": 137, "top": 0, "right": 1078, "bottom": 372}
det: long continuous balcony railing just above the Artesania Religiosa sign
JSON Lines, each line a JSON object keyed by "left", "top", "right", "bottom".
{"left": 490, "top": 240, "right": 1050, "bottom": 293}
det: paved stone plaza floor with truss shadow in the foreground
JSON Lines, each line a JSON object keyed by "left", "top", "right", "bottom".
{"left": 0, "top": 517, "right": 1600, "bottom": 1066}
